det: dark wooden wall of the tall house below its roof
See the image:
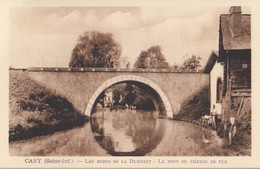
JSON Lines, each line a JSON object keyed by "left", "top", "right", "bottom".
{"left": 222, "top": 50, "right": 251, "bottom": 128}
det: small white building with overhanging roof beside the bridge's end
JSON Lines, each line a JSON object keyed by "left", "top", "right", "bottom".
{"left": 203, "top": 51, "right": 223, "bottom": 118}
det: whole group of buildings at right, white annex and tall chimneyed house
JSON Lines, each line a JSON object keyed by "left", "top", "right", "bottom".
{"left": 204, "top": 6, "right": 251, "bottom": 146}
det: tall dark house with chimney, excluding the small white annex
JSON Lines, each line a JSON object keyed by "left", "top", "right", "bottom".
{"left": 218, "top": 6, "right": 251, "bottom": 124}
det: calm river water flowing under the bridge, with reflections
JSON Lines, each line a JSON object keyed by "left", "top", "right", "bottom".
{"left": 9, "top": 109, "right": 235, "bottom": 156}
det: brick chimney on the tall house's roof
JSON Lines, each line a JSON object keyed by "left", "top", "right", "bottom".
{"left": 229, "top": 6, "right": 242, "bottom": 38}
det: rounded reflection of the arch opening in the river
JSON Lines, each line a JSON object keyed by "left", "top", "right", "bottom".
{"left": 91, "top": 109, "right": 165, "bottom": 156}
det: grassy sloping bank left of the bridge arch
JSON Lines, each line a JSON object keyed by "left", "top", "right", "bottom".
{"left": 9, "top": 70, "right": 86, "bottom": 141}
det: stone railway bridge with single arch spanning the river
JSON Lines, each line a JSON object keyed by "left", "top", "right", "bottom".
{"left": 28, "top": 68, "right": 209, "bottom": 118}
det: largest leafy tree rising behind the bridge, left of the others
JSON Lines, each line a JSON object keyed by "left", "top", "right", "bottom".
{"left": 69, "top": 31, "right": 121, "bottom": 68}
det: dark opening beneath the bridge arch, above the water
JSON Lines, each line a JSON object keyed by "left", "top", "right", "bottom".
{"left": 91, "top": 81, "right": 162, "bottom": 117}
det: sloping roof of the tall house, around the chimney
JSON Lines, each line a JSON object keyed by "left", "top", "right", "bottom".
{"left": 220, "top": 14, "right": 251, "bottom": 50}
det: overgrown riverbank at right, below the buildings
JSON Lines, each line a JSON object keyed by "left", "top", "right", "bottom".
{"left": 174, "top": 88, "right": 251, "bottom": 156}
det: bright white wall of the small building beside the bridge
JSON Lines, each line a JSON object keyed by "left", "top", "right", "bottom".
{"left": 210, "top": 62, "right": 223, "bottom": 115}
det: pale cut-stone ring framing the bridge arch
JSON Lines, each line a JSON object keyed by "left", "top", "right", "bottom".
{"left": 85, "top": 75, "right": 173, "bottom": 118}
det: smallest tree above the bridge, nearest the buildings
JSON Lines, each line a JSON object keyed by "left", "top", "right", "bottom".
{"left": 181, "top": 55, "right": 201, "bottom": 70}
